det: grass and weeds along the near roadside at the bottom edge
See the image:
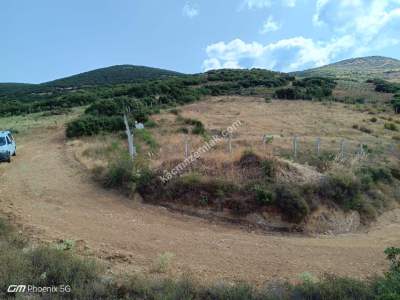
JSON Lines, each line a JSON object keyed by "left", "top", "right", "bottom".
{"left": 0, "top": 219, "right": 400, "bottom": 300}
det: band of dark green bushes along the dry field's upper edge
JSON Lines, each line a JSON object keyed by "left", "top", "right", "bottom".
{"left": 67, "top": 69, "right": 336, "bottom": 137}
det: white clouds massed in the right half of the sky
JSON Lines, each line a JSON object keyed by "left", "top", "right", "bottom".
{"left": 203, "top": 0, "right": 400, "bottom": 71}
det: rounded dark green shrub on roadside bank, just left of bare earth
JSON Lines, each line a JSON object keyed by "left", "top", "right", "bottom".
{"left": 275, "top": 185, "right": 310, "bottom": 223}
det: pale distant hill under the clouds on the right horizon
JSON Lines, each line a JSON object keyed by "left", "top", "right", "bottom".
{"left": 293, "top": 56, "right": 400, "bottom": 81}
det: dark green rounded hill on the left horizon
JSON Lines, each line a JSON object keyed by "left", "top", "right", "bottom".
{"left": 42, "top": 65, "right": 182, "bottom": 87}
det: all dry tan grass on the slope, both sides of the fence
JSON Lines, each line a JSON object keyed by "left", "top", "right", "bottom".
{"left": 72, "top": 96, "right": 398, "bottom": 183}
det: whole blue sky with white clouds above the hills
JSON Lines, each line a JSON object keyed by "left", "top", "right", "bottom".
{"left": 0, "top": 0, "right": 400, "bottom": 83}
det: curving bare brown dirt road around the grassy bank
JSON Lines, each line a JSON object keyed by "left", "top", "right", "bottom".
{"left": 0, "top": 129, "right": 400, "bottom": 284}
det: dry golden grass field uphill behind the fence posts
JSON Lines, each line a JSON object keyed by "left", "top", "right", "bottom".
{"left": 148, "top": 96, "right": 393, "bottom": 165}
